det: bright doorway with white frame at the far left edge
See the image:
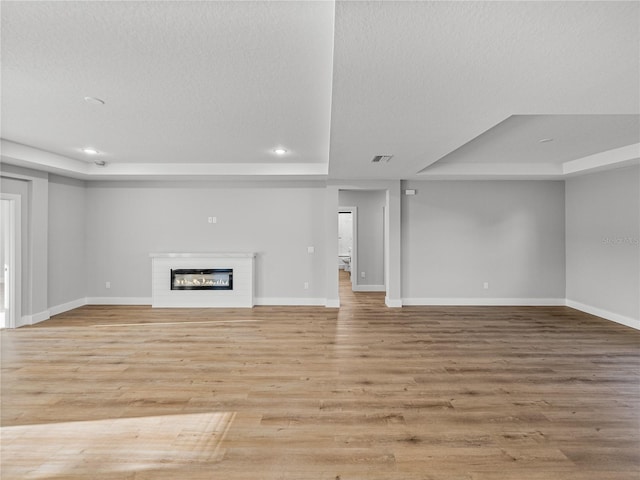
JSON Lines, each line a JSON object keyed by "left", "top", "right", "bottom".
{"left": 0, "top": 193, "right": 21, "bottom": 328}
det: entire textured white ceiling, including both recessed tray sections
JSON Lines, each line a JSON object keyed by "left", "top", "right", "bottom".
{"left": 1, "top": 1, "right": 640, "bottom": 179}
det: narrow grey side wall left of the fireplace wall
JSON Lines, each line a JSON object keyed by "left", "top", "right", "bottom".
{"left": 48, "top": 175, "right": 86, "bottom": 314}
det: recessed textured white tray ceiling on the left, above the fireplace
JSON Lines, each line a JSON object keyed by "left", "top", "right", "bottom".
{"left": 2, "top": 1, "right": 334, "bottom": 177}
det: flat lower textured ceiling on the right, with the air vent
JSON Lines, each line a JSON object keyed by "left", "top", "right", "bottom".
{"left": 330, "top": 2, "right": 640, "bottom": 178}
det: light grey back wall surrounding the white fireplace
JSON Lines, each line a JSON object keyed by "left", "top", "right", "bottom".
{"left": 86, "top": 182, "right": 324, "bottom": 305}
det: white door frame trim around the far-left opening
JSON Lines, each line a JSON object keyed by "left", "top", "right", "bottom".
{"left": 0, "top": 193, "right": 22, "bottom": 328}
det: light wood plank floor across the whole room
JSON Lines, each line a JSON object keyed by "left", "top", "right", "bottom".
{"left": 1, "top": 272, "right": 640, "bottom": 480}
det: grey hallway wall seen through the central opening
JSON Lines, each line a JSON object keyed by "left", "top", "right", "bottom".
{"left": 339, "top": 190, "right": 386, "bottom": 290}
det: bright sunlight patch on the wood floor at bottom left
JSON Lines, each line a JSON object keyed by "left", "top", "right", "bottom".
{"left": 0, "top": 412, "right": 236, "bottom": 478}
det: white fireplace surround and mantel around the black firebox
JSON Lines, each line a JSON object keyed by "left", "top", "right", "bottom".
{"left": 149, "top": 252, "right": 256, "bottom": 308}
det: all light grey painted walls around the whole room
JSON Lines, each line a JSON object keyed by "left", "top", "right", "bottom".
{"left": 1, "top": 161, "right": 640, "bottom": 328}
